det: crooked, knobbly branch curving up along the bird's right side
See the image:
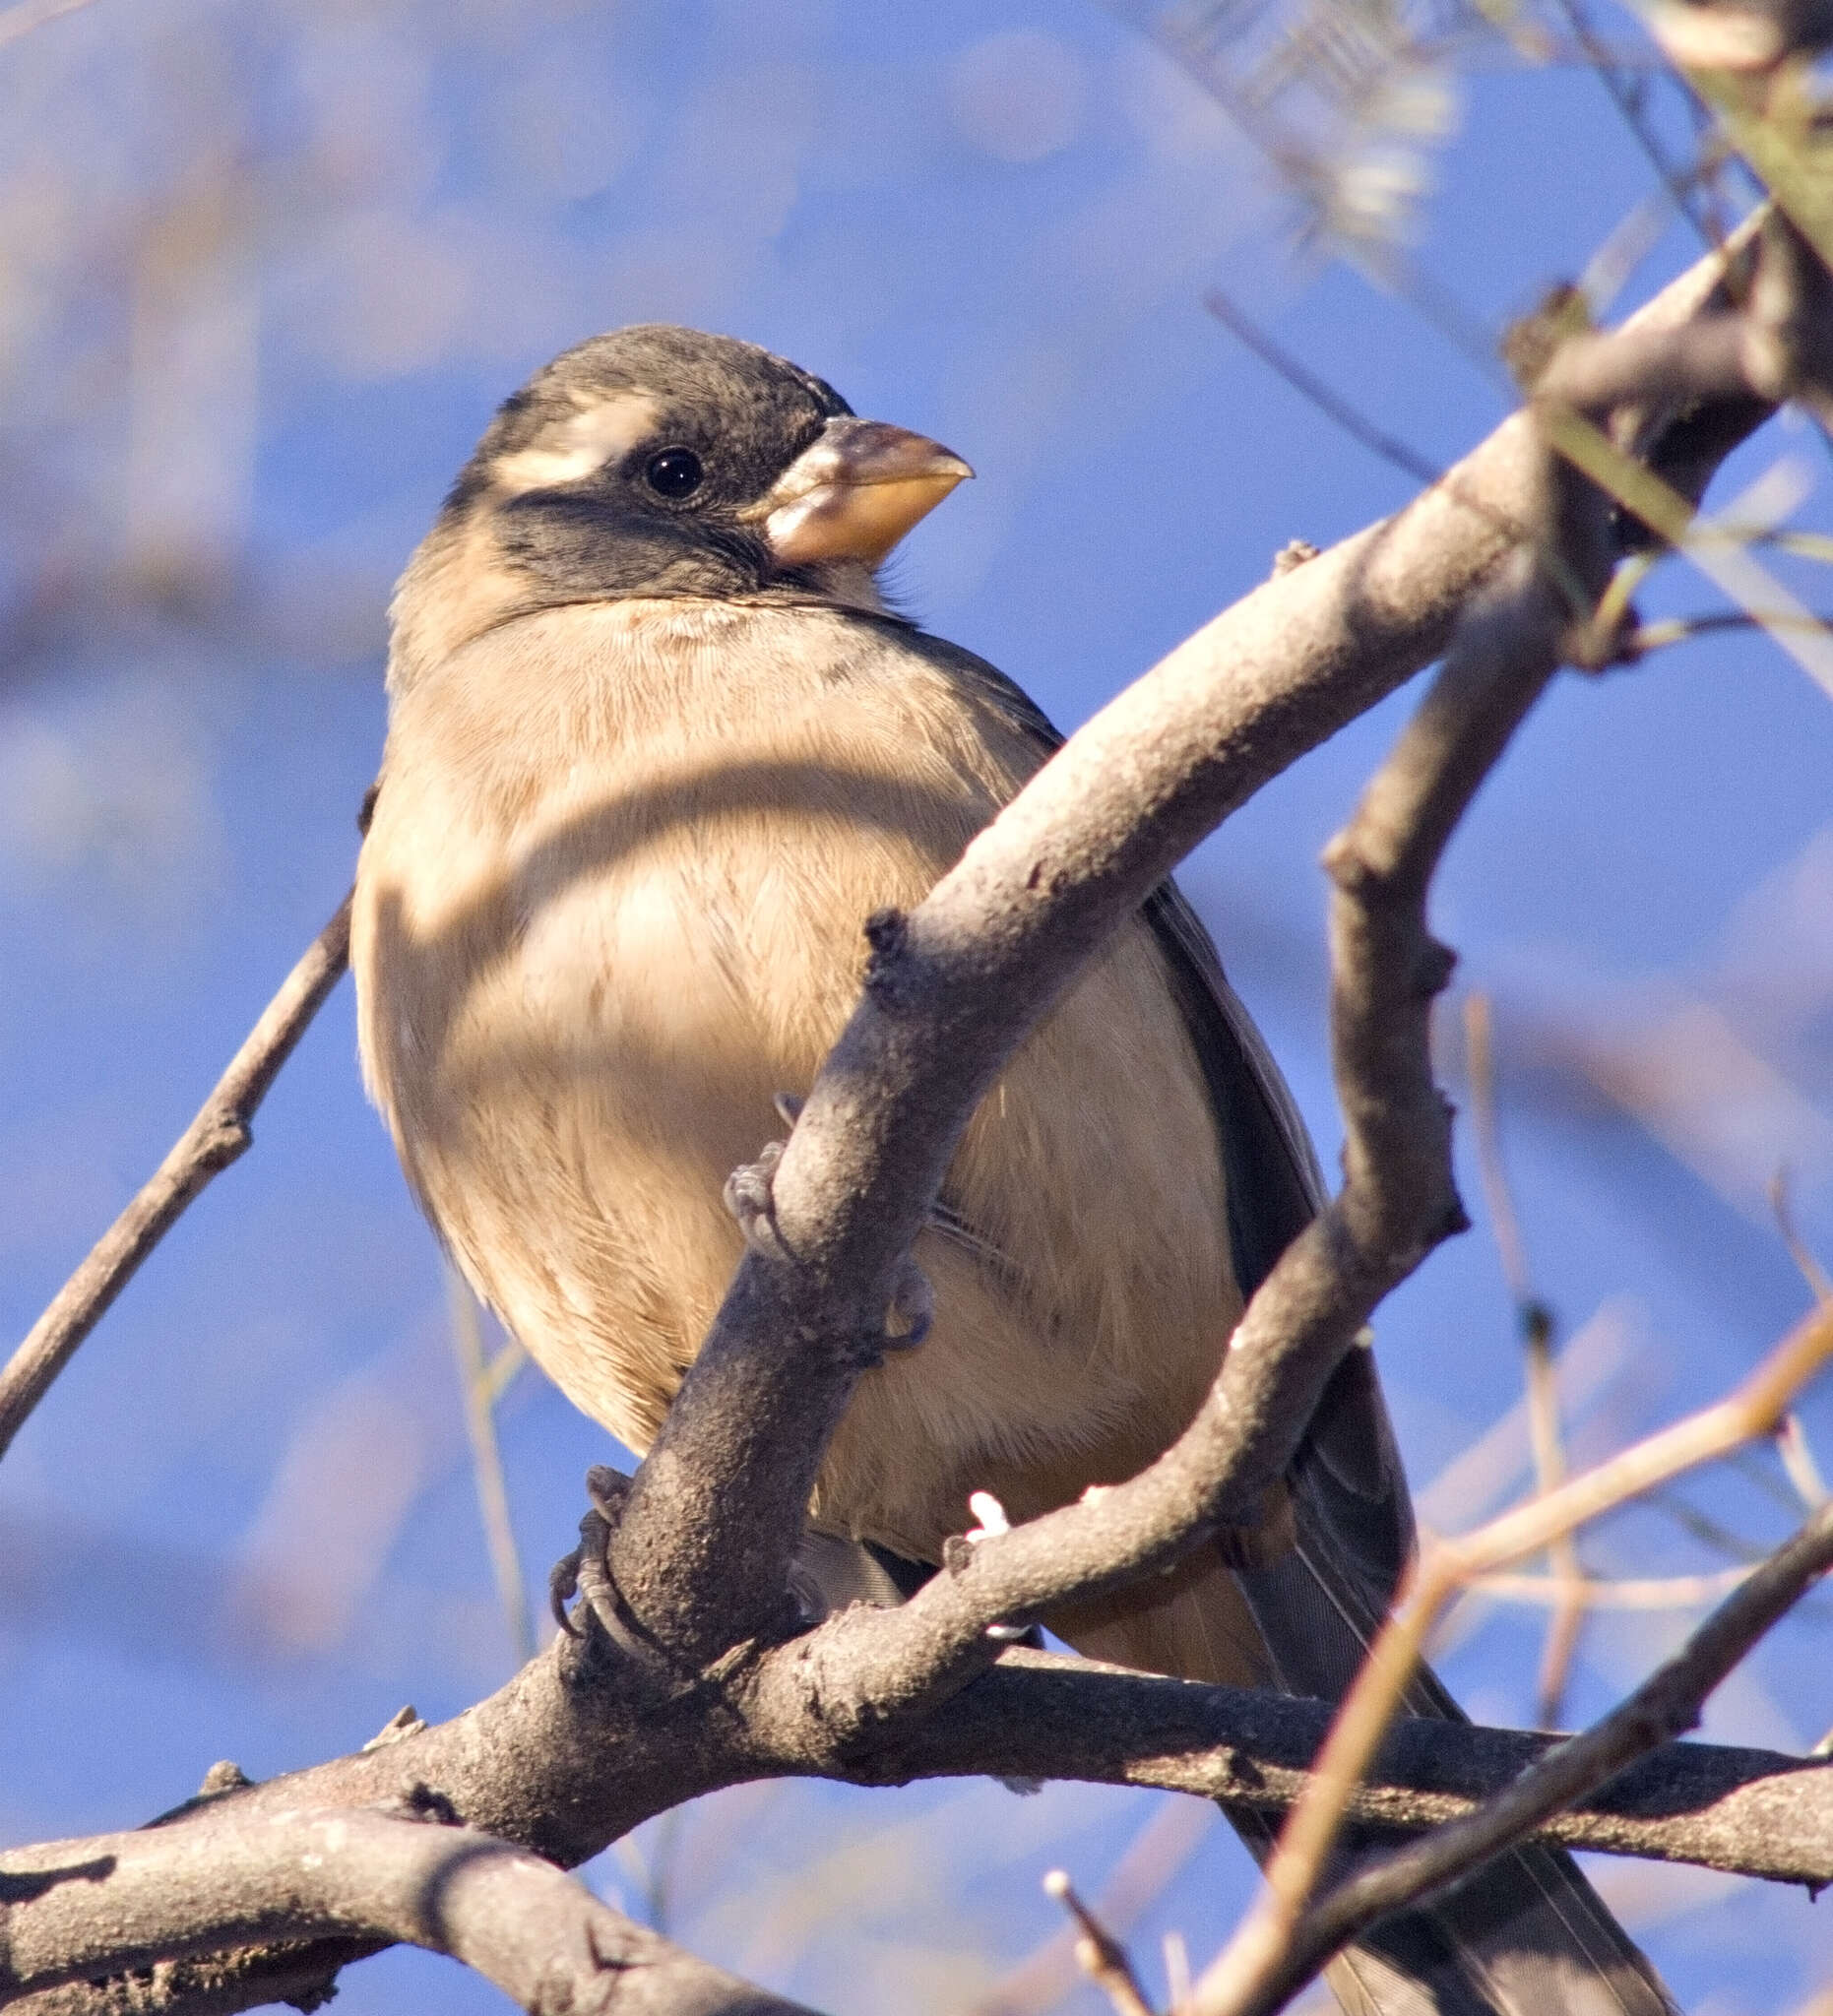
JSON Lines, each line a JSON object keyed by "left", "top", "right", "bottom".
{"left": 741, "top": 554, "right": 1565, "bottom": 1749}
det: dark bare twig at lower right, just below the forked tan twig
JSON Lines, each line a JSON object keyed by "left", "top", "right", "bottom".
{"left": 1198, "top": 1508, "right": 1833, "bottom": 2016}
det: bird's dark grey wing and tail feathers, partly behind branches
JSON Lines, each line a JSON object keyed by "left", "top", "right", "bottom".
{"left": 910, "top": 633, "right": 1674, "bottom": 2016}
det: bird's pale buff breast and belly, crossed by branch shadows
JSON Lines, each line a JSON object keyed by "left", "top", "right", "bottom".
{"left": 352, "top": 597, "right": 1238, "bottom": 1558}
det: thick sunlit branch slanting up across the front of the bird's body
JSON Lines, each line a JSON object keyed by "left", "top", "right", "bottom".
{"left": 609, "top": 224, "right": 1760, "bottom": 1670}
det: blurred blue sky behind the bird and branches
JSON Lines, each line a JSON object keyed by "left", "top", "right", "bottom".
{"left": 0, "top": 0, "right": 1833, "bottom": 2016}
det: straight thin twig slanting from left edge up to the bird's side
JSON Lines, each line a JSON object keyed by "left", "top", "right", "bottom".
{"left": 0, "top": 891, "right": 350, "bottom": 1456}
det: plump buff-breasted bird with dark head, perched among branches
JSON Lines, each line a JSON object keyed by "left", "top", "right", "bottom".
{"left": 350, "top": 325, "right": 1672, "bottom": 2016}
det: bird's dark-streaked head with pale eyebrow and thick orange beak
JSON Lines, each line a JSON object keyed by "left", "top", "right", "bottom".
{"left": 393, "top": 323, "right": 974, "bottom": 671}
